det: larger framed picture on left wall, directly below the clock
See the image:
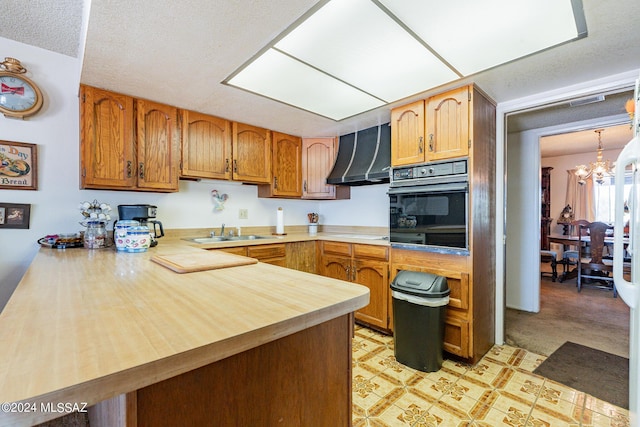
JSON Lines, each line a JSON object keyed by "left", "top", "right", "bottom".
{"left": 0, "top": 141, "right": 38, "bottom": 190}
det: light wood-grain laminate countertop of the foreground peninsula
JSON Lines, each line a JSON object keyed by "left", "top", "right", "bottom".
{"left": 0, "top": 239, "right": 369, "bottom": 426}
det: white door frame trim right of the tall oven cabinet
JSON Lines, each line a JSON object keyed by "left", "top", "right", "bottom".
{"left": 495, "top": 70, "right": 640, "bottom": 344}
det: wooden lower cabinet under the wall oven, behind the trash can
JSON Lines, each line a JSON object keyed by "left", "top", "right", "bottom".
{"left": 390, "top": 249, "right": 495, "bottom": 362}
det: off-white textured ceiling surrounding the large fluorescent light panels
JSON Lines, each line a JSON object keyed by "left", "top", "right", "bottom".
{"left": 0, "top": 0, "right": 640, "bottom": 147}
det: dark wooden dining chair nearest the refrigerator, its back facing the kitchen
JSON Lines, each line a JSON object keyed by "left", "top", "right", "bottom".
{"left": 577, "top": 221, "right": 618, "bottom": 298}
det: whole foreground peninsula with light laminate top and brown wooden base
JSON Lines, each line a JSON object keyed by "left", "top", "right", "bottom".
{"left": 0, "top": 241, "right": 369, "bottom": 426}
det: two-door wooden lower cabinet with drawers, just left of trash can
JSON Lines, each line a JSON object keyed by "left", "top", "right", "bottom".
{"left": 318, "top": 241, "right": 389, "bottom": 330}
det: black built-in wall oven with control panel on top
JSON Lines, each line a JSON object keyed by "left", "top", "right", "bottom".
{"left": 389, "top": 158, "right": 469, "bottom": 254}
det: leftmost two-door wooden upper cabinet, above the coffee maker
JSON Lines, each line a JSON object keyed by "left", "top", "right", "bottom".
{"left": 80, "top": 86, "right": 180, "bottom": 192}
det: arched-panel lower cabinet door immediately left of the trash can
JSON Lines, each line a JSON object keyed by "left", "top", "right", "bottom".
{"left": 353, "top": 259, "right": 389, "bottom": 329}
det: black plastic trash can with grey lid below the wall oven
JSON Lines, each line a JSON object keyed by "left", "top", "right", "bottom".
{"left": 391, "top": 270, "right": 450, "bottom": 372}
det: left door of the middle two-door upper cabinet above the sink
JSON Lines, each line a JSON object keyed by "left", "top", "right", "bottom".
{"left": 181, "top": 110, "right": 231, "bottom": 179}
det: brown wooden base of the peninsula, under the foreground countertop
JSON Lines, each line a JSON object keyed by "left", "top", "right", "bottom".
{"left": 89, "top": 314, "right": 353, "bottom": 427}
